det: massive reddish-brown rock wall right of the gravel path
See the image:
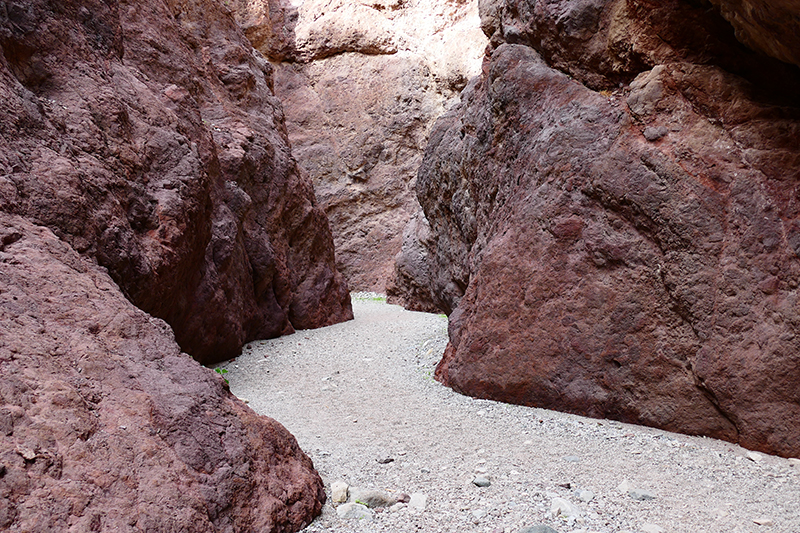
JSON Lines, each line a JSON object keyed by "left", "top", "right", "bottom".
{"left": 405, "top": 0, "right": 800, "bottom": 456}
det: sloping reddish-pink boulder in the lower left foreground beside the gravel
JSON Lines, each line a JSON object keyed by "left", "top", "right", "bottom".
{"left": 0, "top": 213, "right": 325, "bottom": 532}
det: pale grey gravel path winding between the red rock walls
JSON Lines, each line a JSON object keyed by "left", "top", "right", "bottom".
{"left": 224, "top": 295, "right": 800, "bottom": 533}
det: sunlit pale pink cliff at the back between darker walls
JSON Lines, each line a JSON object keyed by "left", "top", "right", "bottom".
{"left": 235, "top": 0, "right": 486, "bottom": 292}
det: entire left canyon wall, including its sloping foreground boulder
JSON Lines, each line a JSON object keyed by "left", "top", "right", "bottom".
{"left": 0, "top": 0, "right": 352, "bottom": 532}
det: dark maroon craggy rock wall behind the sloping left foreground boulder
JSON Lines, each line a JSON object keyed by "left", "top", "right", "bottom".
{"left": 0, "top": 0, "right": 352, "bottom": 362}
